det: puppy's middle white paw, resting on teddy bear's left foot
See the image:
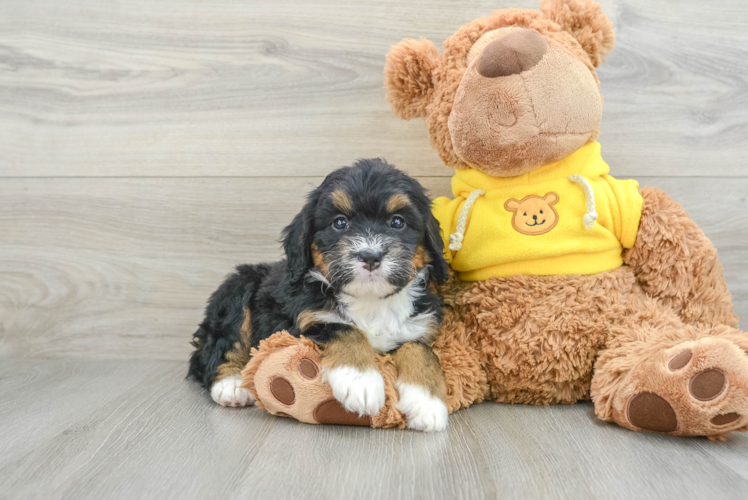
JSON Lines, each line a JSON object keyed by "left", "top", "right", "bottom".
{"left": 322, "top": 366, "right": 384, "bottom": 415}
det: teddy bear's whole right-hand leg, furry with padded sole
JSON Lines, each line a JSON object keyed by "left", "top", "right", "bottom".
{"left": 592, "top": 286, "right": 748, "bottom": 438}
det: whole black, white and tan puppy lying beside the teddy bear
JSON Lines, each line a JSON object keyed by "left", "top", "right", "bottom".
{"left": 189, "top": 159, "right": 447, "bottom": 431}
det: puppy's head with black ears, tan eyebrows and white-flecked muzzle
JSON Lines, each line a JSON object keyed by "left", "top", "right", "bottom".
{"left": 286, "top": 160, "right": 446, "bottom": 297}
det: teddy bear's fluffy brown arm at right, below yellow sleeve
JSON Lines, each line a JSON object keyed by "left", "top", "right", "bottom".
{"left": 624, "top": 187, "right": 738, "bottom": 327}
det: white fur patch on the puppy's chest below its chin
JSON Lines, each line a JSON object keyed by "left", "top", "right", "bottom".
{"left": 344, "top": 297, "right": 435, "bottom": 353}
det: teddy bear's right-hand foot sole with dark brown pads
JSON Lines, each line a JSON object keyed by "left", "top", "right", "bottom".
{"left": 626, "top": 338, "right": 748, "bottom": 435}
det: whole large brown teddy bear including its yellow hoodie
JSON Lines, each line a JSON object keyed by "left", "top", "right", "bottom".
{"left": 244, "top": 0, "right": 748, "bottom": 439}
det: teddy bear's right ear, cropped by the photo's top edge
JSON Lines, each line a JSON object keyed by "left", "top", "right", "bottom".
{"left": 540, "top": 0, "right": 616, "bottom": 68}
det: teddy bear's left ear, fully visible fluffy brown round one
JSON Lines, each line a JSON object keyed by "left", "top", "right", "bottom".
{"left": 384, "top": 39, "right": 439, "bottom": 120}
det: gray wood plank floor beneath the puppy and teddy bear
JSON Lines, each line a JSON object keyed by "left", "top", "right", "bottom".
{"left": 0, "top": 360, "right": 748, "bottom": 500}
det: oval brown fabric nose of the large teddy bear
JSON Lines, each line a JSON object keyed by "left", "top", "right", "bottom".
{"left": 478, "top": 29, "right": 548, "bottom": 78}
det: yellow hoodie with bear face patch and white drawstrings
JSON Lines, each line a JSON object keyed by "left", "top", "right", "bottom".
{"left": 433, "top": 142, "right": 642, "bottom": 281}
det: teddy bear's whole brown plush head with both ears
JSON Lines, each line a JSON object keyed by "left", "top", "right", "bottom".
{"left": 385, "top": 0, "right": 615, "bottom": 177}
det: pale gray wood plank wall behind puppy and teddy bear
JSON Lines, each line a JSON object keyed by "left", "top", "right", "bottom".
{"left": 0, "top": 0, "right": 748, "bottom": 360}
